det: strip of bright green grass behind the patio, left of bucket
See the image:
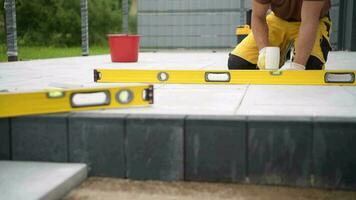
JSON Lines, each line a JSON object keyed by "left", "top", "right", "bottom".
{"left": 0, "top": 45, "right": 109, "bottom": 62}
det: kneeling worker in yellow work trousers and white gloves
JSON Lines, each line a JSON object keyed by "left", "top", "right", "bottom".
{"left": 228, "top": 0, "right": 331, "bottom": 70}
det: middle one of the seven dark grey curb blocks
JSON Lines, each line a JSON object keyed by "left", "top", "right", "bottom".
{"left": 126, "top": 115, "right": 184, "bottom": 181}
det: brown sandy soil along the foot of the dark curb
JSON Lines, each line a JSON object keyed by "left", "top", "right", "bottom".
{"left": 64, "top": 177, "right": 356, "bottom": 200}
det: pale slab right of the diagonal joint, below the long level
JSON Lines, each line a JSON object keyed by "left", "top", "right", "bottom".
{"left": 236, "top": 85, "right": 356, "bottom": 117}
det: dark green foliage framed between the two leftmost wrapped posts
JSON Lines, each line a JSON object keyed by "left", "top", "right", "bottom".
{"left": 16, "top": 0, "right": 76, "bottom": 46}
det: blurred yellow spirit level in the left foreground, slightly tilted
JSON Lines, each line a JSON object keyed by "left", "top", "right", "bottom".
{"left": 0, "top": 85, "right": 153, "bottom": 118}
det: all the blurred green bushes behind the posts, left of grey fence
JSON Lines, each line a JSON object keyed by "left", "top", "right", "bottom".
{"left": 0, "top": 0, "right": 137, "bottom": 47}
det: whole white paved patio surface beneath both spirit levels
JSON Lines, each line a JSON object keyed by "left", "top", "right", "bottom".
{"left": 0, "top": 51, "right": 356, "bottom": 117}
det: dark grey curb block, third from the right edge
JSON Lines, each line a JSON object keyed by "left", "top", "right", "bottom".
{"left": 185, "top": 116, "right": 246, "bottom": 182}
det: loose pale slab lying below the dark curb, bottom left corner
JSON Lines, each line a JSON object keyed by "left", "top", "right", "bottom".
{"left": 0, "top": 161, "right": 87, "bottom": 200}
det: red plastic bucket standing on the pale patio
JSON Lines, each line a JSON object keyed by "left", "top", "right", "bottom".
{"left": 108, "top": 34, "right": 140, "bottom": 62}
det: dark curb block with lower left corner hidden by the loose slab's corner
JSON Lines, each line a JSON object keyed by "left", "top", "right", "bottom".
{"left": 69, "top": 113, "right": 126, "bottom": 178}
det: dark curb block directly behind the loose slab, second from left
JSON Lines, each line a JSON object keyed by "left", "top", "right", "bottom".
{"left": 11, "top": 114, "right": 68, "bottom": 162}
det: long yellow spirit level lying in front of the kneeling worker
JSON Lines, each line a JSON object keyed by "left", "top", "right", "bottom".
{"left": 94, "top": 69, "right": 356, "bottom": 85}
